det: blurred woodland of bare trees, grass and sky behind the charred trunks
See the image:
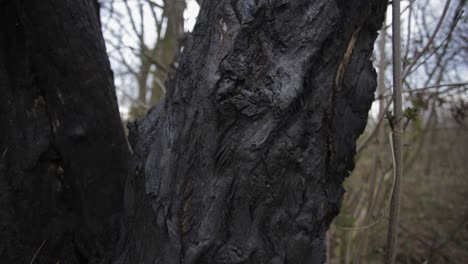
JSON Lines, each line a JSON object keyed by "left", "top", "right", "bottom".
{"left": 100, "top": 0, "right": 468, "bottom": 264}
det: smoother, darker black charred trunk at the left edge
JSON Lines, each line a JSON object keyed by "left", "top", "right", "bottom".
{"left": 0, "top": 0, "right": 128, "bottom": 263}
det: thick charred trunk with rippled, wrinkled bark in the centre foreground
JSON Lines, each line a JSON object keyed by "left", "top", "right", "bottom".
{"left": 117, "top": 0, "right": 387, "bottom": 264}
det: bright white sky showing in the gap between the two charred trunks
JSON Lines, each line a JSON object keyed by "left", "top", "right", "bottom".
{"left": 100, "top": 0, "right": 200, "bottom": 115}
